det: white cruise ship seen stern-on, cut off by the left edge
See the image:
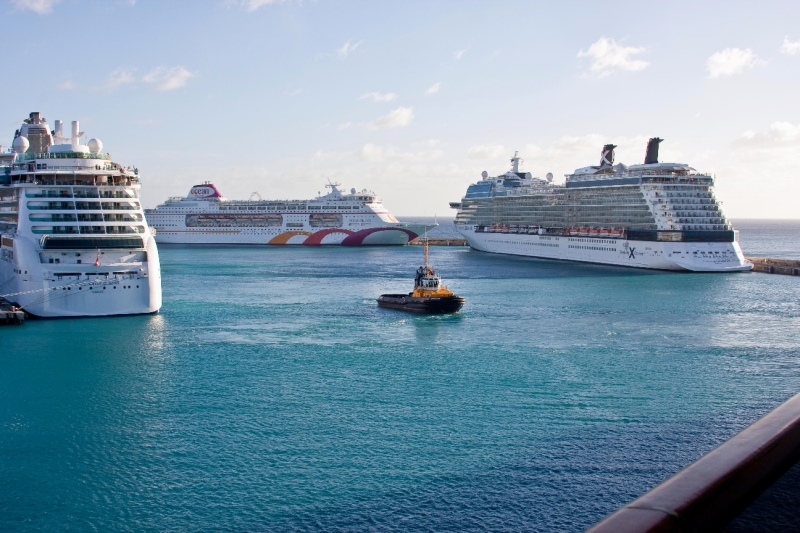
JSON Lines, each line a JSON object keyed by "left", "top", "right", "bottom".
{"left": 0, "top": 113, "right": 161, "bottom": 317}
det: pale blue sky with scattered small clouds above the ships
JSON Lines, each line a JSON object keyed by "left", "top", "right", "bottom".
{"left": 0, "top": 0, "right": 800, "bottom": 219}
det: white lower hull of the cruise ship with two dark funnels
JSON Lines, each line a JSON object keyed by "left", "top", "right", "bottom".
{"left": 456, "top": 226, "right": 753, "bottom": 272}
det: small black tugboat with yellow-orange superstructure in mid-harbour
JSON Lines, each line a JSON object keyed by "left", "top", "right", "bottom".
{"left": 378, "top": 239, "right": 464, "bottom": 314}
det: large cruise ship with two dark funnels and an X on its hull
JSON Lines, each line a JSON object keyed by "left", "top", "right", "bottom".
{"left": 450, "top": 138, "right": 753, "bottom": 272}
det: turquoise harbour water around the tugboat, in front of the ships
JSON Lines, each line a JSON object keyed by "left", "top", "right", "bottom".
{"left": 0, "top": 246, "right": 800, "bottom": 531}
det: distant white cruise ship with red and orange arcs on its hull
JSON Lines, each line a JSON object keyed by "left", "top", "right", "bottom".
{"left": 145, "top": 182, "right": 433, "bottom": 246}
